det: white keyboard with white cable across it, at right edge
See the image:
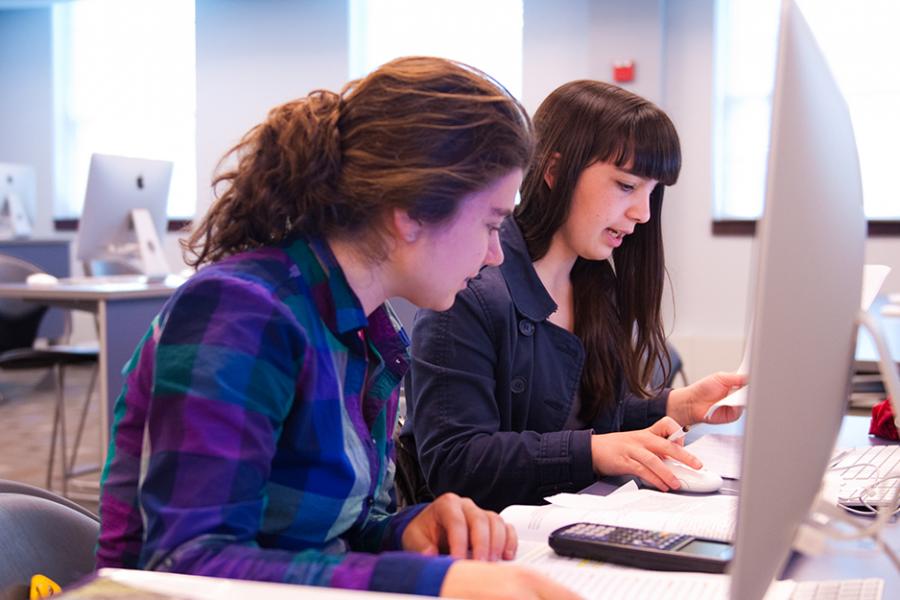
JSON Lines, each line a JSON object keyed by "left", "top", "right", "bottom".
{"left": 830, "top": 444, "right": 900, "bottom": 506}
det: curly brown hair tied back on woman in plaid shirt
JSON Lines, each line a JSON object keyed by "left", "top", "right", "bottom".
{"left": 182, "top": 57, "right": 533, "bottom": 267}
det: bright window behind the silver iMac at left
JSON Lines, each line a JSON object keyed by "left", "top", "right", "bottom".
{"left": 53, "top": 0, "right": 197, "bottom": 219}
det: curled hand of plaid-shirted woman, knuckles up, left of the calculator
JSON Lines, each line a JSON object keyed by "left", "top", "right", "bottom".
{"left": 402, "top": 493, "right": 518, "bottom": 560}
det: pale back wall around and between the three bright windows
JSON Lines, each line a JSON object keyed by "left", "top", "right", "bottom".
{"left": 0, "top": 0, "right": 900, "bottom": 368}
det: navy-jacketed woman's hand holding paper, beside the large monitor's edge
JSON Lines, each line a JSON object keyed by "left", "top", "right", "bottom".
{"left": 666, "top": 373, "right": 747, "bottom": 425}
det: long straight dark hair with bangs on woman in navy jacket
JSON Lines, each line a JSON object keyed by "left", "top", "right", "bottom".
{"left": 515, "top": 81, "right": 681, "bottom": 422}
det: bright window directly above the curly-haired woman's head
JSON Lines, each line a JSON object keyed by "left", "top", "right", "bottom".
{"left": 350, "top": 0, "right": 523, "bottom": 97}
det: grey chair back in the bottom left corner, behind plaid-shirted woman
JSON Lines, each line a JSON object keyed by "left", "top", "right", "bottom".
{"left": 0, "top": 481, "right": 100, "bottom": 598}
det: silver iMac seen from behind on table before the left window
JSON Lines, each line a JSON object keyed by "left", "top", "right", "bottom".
{"left": 77, "top": 154, "right": 172, "bottom": 275}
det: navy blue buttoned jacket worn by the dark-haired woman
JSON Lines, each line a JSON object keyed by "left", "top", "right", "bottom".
{"left": 402, "top": 218, "right": 669, "bottom": 510}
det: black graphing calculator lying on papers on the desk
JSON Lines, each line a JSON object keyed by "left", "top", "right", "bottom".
{"left": 550, "top": 523, "right": 734, "bottom": 573}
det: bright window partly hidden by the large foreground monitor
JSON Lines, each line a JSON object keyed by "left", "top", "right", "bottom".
{"left": 714, "top": 0, "right": 900, "bottom": 220}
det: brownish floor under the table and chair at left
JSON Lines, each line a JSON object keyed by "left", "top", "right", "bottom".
{"left": 0, "top": 366, "right": 100, "bottom": 511}
